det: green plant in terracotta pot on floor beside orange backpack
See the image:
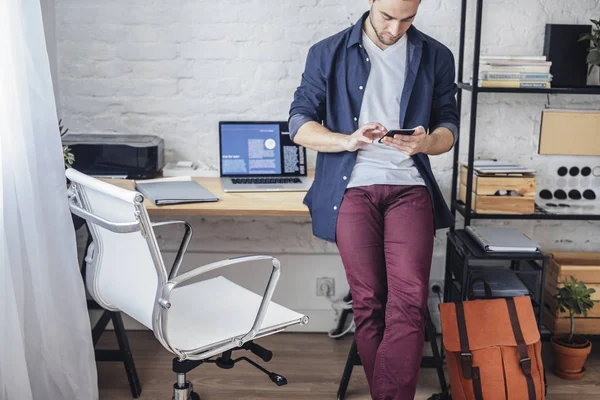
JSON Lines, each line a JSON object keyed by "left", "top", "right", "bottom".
{"left": 550, "top": 277, "right": 596, "bottom": 380}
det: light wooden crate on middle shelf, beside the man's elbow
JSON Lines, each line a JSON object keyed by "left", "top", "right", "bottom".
{"left": 459, "top": 165, "right": 535, "bottom": 214}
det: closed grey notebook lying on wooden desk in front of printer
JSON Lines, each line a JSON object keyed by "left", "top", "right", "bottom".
{"left": 135, "top": 178, "right": 219, "bottom": 206}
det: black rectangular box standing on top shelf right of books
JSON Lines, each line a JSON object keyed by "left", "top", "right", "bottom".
{"left": 544, "top": 24, "right": 592, "bottom": 88}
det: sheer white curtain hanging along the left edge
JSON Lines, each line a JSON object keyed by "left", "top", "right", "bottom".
{"left": 0, "top": 0, "right": 98, "bottom": 400}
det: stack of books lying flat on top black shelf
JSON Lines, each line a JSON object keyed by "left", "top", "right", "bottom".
{"left": 478, "top": 56, "right": 552, "bottom": 89}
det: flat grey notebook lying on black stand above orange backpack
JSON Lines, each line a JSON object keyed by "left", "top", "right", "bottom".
{"left": 465, "top": 225, "right": 540, "bottom": 253}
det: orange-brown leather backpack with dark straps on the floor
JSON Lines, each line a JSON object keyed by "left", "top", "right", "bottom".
{"left": 440, "top": 281, "right": 545, "bottom": 400}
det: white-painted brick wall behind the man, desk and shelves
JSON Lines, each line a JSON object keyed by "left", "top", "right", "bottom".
{"left": 55, "top": 0, "right": 600, "bottom": 330}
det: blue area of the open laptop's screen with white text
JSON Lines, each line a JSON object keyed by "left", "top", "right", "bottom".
{"left": 221, "top": 124, "right": 281, "bottom": 175}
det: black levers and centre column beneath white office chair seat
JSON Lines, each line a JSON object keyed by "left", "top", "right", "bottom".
{"left": 173, "top": 341, "right": 287, "bottom": 400}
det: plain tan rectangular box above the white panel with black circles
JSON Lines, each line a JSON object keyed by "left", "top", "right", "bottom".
{"left": 539, "top": 110, "right": 600, "bottom": 156}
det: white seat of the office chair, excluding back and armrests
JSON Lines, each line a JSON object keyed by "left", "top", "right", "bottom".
{"left": 167, "top": 276, "right": 304, "bottom": 350}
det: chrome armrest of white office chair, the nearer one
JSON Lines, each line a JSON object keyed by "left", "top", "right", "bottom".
{"left": 158, "top": 255, "right": 281, "bottom": 354}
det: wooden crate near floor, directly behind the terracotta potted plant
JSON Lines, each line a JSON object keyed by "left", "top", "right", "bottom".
{"left": 544, "top": 252, "right": 600, "bottom": 335}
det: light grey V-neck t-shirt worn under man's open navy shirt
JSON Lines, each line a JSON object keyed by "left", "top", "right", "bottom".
{"left": 348, "top": 31, "right": 425, "bottom": 187}
